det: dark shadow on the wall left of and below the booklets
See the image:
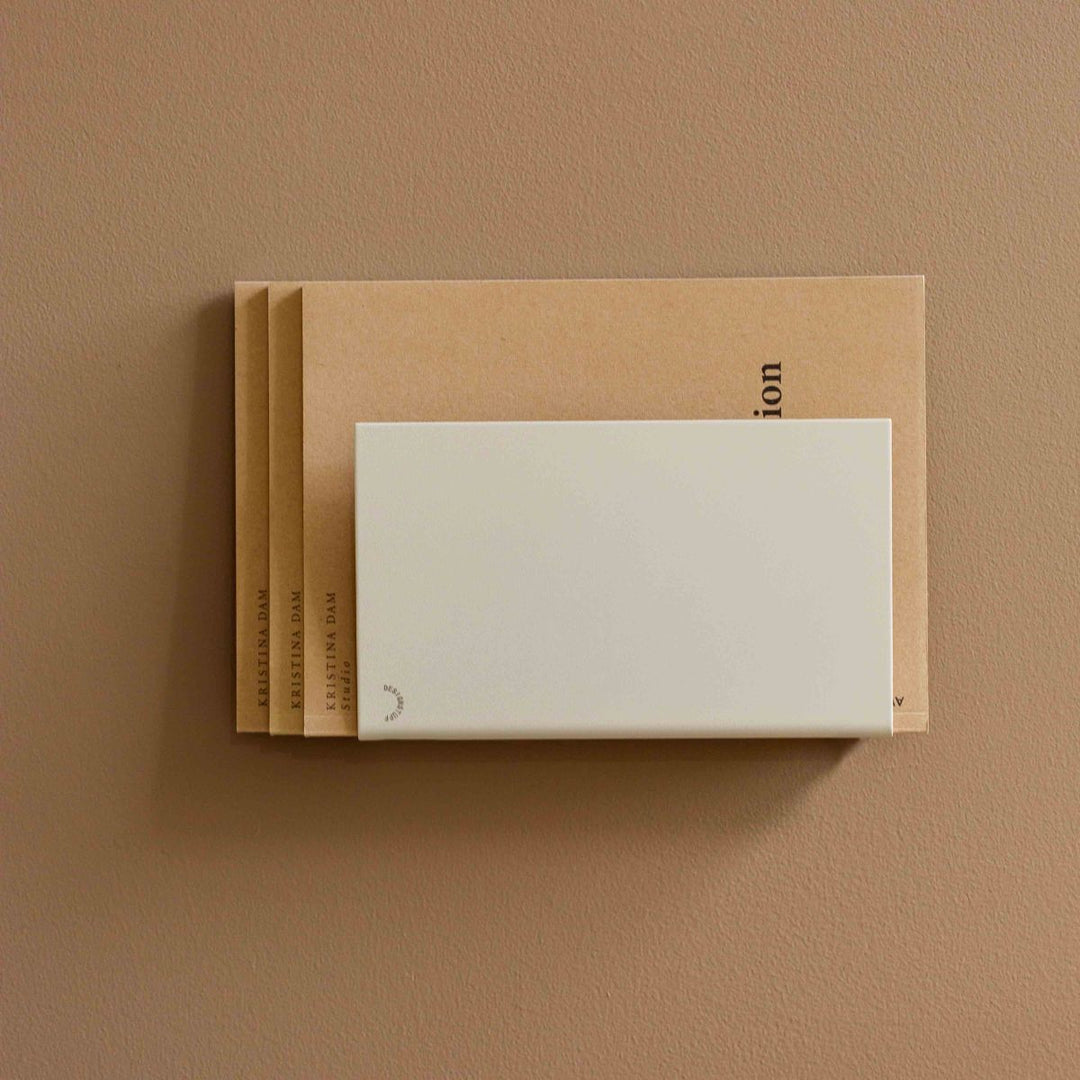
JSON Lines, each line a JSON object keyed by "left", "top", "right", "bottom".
{"left": 154, "top": 296, "right": 859, "bottom": 848}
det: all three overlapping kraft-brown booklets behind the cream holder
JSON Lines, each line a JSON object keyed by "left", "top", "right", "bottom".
{"left": 235, "top": 276, "right": 929, "bottom": 738}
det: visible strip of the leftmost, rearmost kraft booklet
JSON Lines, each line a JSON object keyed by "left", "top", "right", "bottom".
{"left": 233, "top": 282, "right": 270, "bottom": 731}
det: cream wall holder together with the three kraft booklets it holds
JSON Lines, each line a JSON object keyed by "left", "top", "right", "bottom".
{"left": 235, "top": 276, "right": 928, "bottom": 738}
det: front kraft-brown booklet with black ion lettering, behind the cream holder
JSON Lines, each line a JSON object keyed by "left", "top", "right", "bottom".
{"left": 302, "top": 276, "right": 929, "bottom": 735}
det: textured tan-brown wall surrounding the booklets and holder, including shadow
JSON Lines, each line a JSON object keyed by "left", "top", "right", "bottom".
{"left": 0, "top": 0, "right": 1080, "bottom": 1078}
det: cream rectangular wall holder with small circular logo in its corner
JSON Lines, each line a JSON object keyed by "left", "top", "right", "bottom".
{"left": 355, "top": 420, "right": 892, "bottom": 739}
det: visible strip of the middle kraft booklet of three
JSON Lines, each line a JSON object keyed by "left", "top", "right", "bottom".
{"left": 268, "top": 282, "right": 303, "bottom": 734}
